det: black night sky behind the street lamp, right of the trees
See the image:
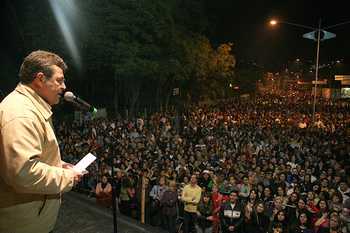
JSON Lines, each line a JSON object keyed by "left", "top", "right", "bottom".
{"left": 209, "top": 0, "right": 350, "bottom": 69}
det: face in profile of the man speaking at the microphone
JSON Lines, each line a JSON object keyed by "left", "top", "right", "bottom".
{"left": 39, "top": 65, "right": 66, "bottom": 105}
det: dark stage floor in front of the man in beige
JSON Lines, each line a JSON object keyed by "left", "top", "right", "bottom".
{"left": 54, "top": 192, "right": 165, "bottom": 233}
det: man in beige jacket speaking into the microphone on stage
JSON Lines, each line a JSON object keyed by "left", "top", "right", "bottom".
{"left": 0, "top": 51, "right": 81, "bottom": 233}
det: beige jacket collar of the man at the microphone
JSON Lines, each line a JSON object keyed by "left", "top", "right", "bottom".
{"left": 16, "top": 83, "right": 52, "bottom": 120}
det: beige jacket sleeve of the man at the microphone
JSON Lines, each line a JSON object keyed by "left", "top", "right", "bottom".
{"left": 0, "top": 117, "right": 74, "bottom": 194}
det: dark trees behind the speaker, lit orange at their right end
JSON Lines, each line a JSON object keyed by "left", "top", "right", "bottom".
{"left": 1, "top": 0, "right": 258, "bottom": 114}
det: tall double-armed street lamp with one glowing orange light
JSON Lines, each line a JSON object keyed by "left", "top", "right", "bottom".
{"left": 270, "top": 19, "right": 350, "bottom": 123}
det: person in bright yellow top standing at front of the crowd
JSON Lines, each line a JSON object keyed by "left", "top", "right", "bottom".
{"left": 181, "top": 175, "right": 202, "bottom": 233}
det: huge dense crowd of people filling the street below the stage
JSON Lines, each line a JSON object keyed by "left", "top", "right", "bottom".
{"left": 56, "top": 94, "right": 350, "bottom": 233}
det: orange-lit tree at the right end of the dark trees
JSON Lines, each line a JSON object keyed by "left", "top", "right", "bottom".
{"left": 178, "top": 35, "right": 236, "bottom": 101}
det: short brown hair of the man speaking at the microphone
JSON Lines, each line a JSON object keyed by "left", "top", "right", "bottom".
{"left": 19, "top": 50, "right": 67, "bottom": 84}
